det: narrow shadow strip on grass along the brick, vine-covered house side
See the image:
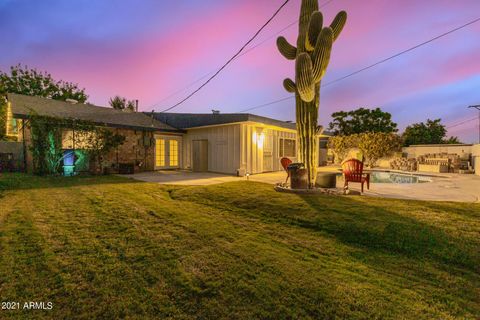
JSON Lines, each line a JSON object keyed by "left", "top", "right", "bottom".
{"left": 0, "top": 173, "right": 142, "bottom": 192}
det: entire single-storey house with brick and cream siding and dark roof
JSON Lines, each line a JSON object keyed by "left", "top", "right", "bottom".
{"left": 0, "top": 94, "right": 327, "bottom": 176}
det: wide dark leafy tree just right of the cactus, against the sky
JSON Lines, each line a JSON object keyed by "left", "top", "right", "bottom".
{"left": 329, "top": 108, "right": 398, "bottom": 136}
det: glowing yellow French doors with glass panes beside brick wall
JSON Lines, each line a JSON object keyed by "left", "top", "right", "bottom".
{"left": 155, "top": 136, "right": 181, "bottom": 170}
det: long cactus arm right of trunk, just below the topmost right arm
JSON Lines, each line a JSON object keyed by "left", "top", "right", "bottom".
{"left": 312, "top": 27, "right": 333, "bottom": 82}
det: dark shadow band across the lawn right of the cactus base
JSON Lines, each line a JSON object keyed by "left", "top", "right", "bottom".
{"left": 295, "top": 196, "right": 480, "bottom": 272}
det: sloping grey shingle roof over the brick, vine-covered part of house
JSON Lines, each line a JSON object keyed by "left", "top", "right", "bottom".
{"left": 7, "top": 93, "right": 179, "bottom": 132}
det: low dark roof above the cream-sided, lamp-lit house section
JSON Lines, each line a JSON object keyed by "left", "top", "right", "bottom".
{"left": 145, "top": 112, "right": 296, "bottom": 130}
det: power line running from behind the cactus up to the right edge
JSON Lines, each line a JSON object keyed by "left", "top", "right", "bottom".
{"left": 238, "top": 18, "right": 480, "bottom": 112}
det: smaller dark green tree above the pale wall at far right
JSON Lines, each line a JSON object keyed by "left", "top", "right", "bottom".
{"left": 402, "top": 119, "right": 461, "bottom": 146}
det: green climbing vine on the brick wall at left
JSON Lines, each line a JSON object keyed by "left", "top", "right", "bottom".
{"left": 29, "top": 113, "right": 125, "bottom": 175}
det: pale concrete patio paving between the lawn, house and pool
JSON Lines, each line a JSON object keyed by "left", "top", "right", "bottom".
{"left": 126, "top": 167, "right": 480, "bottom": 202}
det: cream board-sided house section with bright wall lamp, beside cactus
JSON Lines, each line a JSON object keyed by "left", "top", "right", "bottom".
{"left": 150, "top": 113, "right": 327, "bottom": 176}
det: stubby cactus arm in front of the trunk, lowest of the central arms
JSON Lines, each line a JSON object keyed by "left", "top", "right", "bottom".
{"left": 295, "top": 52, "right": 315, "bottom": 102}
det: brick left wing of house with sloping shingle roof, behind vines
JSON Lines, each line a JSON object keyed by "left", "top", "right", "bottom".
{"left": 4, "top": 94, "right": 183, "bottom": 172}
